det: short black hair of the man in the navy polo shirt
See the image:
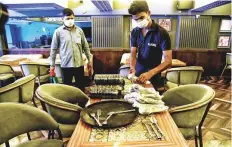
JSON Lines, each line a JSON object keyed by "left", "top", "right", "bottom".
{"left": 128, "top": 0, "right": 149, "bottom": 15}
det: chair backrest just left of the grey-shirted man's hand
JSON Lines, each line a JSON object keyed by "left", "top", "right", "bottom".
{"left": 20, "top": 62, "right": 50, "bottom": 77}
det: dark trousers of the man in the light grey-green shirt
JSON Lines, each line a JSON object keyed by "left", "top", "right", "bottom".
{"left": 62, "top": 66, "right": 85, "bottom": 91}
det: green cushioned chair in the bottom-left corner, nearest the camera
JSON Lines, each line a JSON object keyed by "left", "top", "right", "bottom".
{"left": 0, "top": 103, "right": 63, "bottom": 147}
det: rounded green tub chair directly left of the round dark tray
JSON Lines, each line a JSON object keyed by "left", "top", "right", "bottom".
{"left": 36, "top": 84, "right": 89, "bottom": 137}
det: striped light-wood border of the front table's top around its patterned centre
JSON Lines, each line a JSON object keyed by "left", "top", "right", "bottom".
{"left": 67, "top": 100, "right": 188, "bottom": 147}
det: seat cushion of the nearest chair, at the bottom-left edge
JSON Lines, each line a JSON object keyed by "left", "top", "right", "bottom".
{"left": 16, "top": 139, "right": 64, "bottom": 147}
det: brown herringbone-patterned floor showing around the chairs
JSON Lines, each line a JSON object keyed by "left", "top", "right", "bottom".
{"left": 0, "top": 77, "right": 232, "bottom": 147}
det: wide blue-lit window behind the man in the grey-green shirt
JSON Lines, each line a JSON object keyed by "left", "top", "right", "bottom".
{"left": 5, "top": 17, "right": 92, "bottom": 49}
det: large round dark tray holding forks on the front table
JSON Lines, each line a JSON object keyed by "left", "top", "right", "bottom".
{"left": 81, "top": 100, "right": 139, "bottom": 128}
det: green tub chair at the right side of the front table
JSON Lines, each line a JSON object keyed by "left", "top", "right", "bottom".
{"left": 162, "top": 84, "right": 215, "bottom": 147}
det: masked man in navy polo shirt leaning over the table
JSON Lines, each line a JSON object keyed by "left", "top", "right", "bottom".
{"left": 128, "top": 1, "right": 172, "bottom": 89}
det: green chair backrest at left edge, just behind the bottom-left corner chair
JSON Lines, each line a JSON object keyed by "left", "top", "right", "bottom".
{"left": 0, "top": 75, "right": 35, "bottom": 103}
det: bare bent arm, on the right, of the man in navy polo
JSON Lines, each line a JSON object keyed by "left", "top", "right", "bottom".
{"left": 138, "top": 50, "right": 172, "bottom": 83}
